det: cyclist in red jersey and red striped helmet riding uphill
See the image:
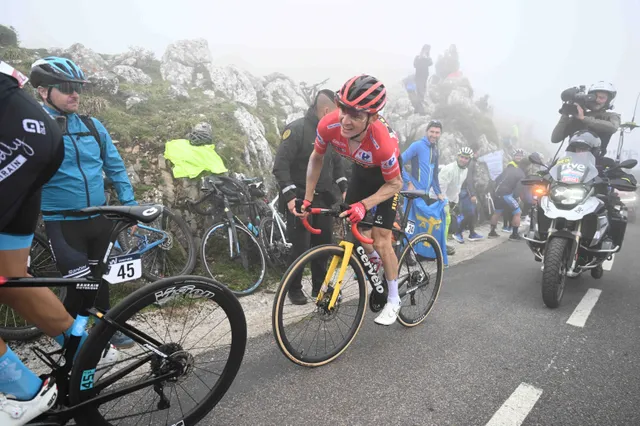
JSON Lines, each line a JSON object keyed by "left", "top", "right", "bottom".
{"left": 300, "top": 75, "right": 402, "bottom": 325}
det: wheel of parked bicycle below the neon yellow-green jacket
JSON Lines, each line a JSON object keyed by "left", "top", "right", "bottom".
{"left": 201, "top": 222, "right": 267, "bottom": 296}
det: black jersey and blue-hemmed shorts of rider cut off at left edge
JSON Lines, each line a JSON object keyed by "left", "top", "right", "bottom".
{"left": 0, "top": 74, "right": 64, "bottom": 250}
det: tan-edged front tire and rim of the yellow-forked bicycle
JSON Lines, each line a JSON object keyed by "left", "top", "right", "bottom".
{"left": 271, "top": 244, "right": 369, "bottom": 367}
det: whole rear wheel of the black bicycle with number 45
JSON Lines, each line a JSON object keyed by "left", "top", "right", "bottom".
{"left": 69, "top": 276, "right": 247, "bottom": 426}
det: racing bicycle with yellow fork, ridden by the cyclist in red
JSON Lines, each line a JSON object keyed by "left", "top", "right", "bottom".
{"left": 272, "top": 190, "right": 444, "bottom": 367}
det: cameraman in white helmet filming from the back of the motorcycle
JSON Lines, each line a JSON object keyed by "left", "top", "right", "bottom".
{"left": 551, "top": 81, "right": 620, "bottom": 158}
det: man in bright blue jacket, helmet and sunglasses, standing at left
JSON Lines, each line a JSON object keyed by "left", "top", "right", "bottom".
{"left": 30, "top": 56, "right": 137, "bottom": 348}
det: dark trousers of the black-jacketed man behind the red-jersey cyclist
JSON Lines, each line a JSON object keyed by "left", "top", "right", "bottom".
{"left": 287, "top": 195, "right": 333, "bottom": 290}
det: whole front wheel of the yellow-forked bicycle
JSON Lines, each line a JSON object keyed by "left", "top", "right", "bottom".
{"left": 272, "top": 245, "right": 369, "bottom": 367}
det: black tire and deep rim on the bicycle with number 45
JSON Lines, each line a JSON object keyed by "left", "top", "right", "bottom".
{"left": 69, "top": 275, "right": 247, "bottom": 426}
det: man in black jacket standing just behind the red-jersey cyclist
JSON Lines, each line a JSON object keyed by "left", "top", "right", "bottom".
{"left": 273, "top": 90, "right": 347, "bottom": 305}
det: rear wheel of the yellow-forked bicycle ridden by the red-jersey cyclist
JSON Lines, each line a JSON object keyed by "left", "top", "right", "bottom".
{"left": 398, "top": 234, "right": 444, "bottom": 327}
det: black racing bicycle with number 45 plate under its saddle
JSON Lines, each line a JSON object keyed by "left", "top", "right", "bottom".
{"left": 0, "top": 205, "right": 247, "bottom": 426}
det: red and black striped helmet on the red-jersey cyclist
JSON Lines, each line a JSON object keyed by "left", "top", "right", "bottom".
{"left": 336, "top": 74, "right": 387, "bottom": 114}
